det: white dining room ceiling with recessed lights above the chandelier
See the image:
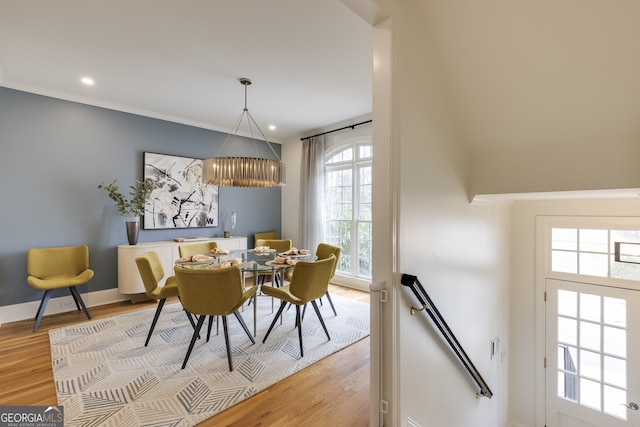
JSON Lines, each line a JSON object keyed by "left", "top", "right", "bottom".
{"left": 0, "top": 0, "right": 372, "bottom": 142}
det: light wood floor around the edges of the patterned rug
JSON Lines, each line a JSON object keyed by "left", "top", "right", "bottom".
{"left": 0, "top": 285, "right": 369, "bottom": 427}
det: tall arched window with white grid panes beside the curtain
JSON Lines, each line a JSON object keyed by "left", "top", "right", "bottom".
{"left": 325, "top": 138, "right": 373, "bottom": 279}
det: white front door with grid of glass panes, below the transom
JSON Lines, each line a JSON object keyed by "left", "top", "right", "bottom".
{"left": 545, "top": 279, "right": 640, "bottom": 427}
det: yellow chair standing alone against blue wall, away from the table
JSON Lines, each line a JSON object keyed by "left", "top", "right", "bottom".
{"left": 27, "top": 245, "right": 93, "bottom": 332}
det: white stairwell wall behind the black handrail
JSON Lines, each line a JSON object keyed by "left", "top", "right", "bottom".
{"left": 374, "top": 1, "right": 510, "bottom": 427}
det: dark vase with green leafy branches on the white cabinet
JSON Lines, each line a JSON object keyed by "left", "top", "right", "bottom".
{"left": 98, "top": 180, "right": 155, "bottom": 245}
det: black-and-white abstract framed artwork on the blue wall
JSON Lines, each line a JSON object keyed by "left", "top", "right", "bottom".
{"left": 144, "top": 152, "right": 218, "bottom": 230}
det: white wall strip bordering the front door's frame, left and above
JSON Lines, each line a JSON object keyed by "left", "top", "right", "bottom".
{"left": 508, "top": 198, "right": 640, "bottom": 427}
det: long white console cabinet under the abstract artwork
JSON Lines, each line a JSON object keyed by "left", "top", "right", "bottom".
{"left": 118, "top": 237, "right": 247, "bottom": 300}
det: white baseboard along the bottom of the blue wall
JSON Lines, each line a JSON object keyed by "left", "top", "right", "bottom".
{"left": 0, "top": 288, "right": 131, "bottom": 327}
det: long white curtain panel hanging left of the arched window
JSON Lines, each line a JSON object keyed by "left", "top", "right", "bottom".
{"left": 299, "top": 135, "right": 325, "bottom": 250}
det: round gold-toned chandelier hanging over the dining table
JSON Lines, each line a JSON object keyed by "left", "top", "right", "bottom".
{"left": 202, "top": 78, "right": 287, "bottom": 187}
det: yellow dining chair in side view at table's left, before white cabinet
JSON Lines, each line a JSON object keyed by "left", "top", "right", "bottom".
{"left": 136, "top": 251, "right": 195, "bottom": 347}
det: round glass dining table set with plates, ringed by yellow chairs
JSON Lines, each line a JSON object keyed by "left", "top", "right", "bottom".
{"left": 176, "top": 249, "right": 312, "bottom": 337}
